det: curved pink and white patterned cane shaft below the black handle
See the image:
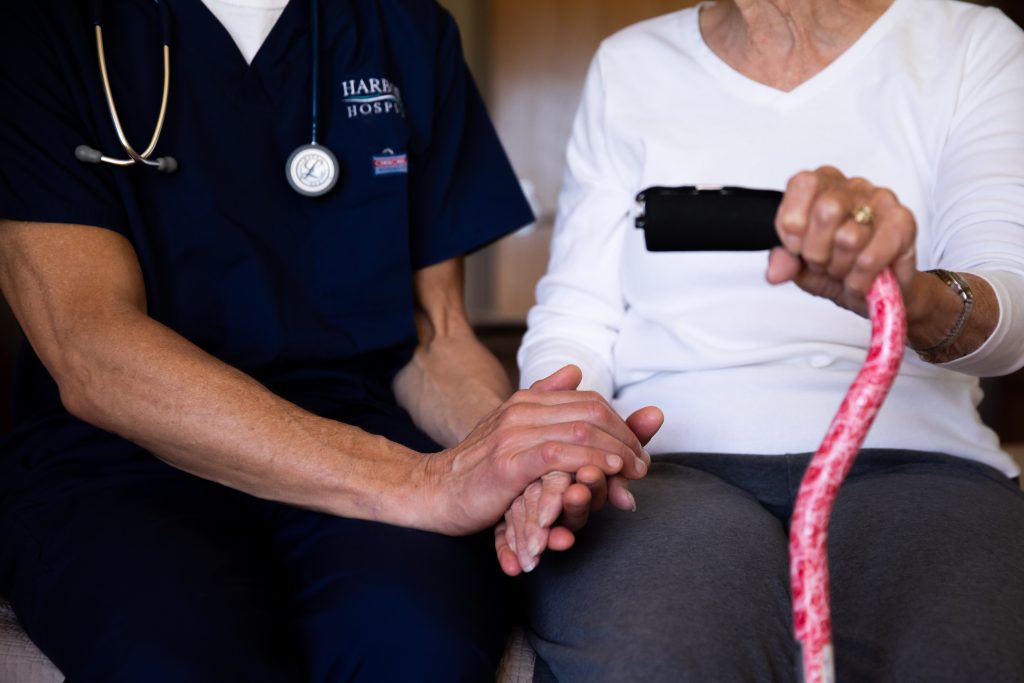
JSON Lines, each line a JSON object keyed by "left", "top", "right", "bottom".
{"left": 790, "top": 270, "right": 906, "bottom": 683}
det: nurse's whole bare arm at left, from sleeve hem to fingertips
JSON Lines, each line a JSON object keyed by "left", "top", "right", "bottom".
{"left": 0, "top": 221, "right": 644, "bottom": 535}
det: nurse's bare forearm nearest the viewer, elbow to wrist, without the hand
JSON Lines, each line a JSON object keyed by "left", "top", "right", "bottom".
{"left": 56, "top": 312, "right": 436, "bottom": 526}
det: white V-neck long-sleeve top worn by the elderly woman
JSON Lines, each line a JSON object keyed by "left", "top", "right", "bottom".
{"left": 519, "top": 0, "right": 1024, "bottom": 476}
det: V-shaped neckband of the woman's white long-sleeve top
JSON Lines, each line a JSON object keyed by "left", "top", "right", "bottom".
{"left": 683, "top": 0, "right": 907, "bottom": 110}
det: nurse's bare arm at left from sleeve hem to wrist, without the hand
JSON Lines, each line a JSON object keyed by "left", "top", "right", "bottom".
{"left": 0, "top": 221, "right": 428, "bottom": 527}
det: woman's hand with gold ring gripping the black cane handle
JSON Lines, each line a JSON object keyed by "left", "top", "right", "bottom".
{"left": 768, "top": 166, "right": 918, "bottom": 315}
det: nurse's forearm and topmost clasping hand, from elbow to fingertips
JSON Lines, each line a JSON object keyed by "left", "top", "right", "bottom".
{"left": 55, "top": 313, "right": 646, "bottom": 535}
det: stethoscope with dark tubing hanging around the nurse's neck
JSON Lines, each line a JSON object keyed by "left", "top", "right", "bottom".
{"left": 75, "top": 0, "right": 338, "bottom": 197}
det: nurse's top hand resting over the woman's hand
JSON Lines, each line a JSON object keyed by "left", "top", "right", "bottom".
{"left": 418, "top": 366, "right": 647, "bottom": 536}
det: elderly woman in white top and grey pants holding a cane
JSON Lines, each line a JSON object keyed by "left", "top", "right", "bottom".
{"left": 498, "top": 0, "right": 1024, "bottom": 683}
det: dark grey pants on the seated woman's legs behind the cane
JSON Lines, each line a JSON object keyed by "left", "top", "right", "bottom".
{"left": 528, "top": 451, "right": 1024, "bottom": 683}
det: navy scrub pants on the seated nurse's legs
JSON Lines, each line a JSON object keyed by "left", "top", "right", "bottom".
{"left": 0, "top": 450, "right": 505, "bottom": 683}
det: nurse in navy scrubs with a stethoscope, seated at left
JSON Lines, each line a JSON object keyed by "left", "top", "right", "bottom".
{"left": 0, "top": 0, "right": 658, "bottom": 683}
